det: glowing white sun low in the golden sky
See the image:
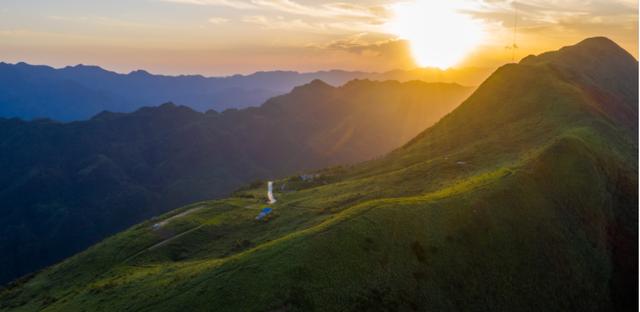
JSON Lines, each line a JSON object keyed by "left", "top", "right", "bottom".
{"left": 385, "top": 0, "right": 484, "bottom": 69}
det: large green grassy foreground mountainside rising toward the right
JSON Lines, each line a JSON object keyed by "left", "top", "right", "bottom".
{"left": 0, "top": 39, "right": 638, "bottom": 311}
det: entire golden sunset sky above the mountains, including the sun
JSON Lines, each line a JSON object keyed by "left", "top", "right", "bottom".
{"left": 0, "top": 0, "right": 638, "bottom": 76}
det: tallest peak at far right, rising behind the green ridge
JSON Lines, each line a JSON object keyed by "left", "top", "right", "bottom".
{"left": 424, "top": 37, "right": 638, "bottom": 140}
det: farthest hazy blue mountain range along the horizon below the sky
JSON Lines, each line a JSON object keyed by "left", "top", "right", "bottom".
{"left": 0, "top": 63, "right": 491, "bottom": 121}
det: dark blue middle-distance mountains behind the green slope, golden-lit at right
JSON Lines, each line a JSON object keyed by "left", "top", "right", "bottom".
{"left": 0, "top": 80, "right": 472, "bottom": 282}
